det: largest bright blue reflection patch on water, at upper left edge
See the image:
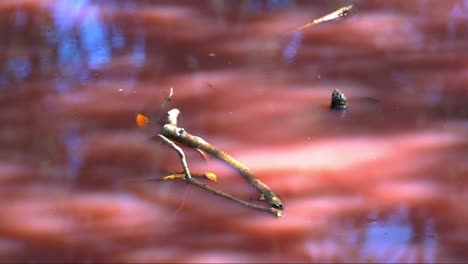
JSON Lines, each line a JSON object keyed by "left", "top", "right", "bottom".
{"left": 48, "top": 0, "right": 115, "bottom": 92}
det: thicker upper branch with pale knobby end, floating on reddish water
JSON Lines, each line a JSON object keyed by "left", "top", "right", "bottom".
{"left": 158, "top": 109, "right": 284, "bottom": 210}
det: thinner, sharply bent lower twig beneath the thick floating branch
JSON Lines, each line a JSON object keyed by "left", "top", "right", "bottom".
{"left": 158, "top": 134, "right": 282, "bottom": 217}
